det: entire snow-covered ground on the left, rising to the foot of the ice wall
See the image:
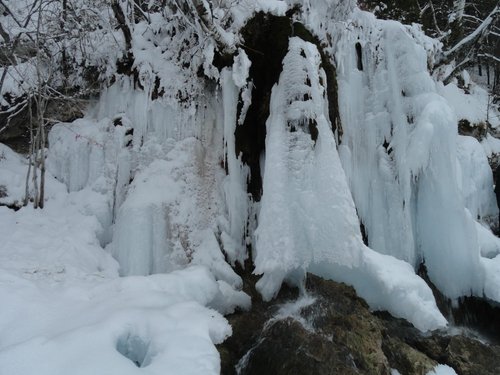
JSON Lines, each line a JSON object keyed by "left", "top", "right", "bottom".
{"left": 0, "top": 146, "right": 240, "bottom": 374}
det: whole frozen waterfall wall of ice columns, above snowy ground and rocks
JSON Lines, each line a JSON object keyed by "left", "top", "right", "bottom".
{"left": 43, "top": 1, "right": 498, "bottom": 330}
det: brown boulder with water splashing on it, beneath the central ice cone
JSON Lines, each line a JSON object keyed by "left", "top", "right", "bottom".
{"left": 220, "top": 276, "right": 390, "bottom": 375}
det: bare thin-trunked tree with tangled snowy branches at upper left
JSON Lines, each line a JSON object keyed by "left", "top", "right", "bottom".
{"left": 0, "top": 0, "right": 109, "bottom": 208}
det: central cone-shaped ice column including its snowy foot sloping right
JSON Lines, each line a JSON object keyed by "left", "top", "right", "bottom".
{"left": 255, "top": 38, "right": 446, "bottom": 331}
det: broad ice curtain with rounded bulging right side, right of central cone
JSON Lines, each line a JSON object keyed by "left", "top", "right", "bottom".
{"left": 336, "top": 12, "right": 483, "bottom": 297}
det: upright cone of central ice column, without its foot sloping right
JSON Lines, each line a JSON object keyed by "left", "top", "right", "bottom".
{"left": 255, "top": 38, "right": 363, "bottom": 299}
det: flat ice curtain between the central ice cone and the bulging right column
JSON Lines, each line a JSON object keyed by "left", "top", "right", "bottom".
{"left": 336, "top": 13, "right": 417, "bottom": 264}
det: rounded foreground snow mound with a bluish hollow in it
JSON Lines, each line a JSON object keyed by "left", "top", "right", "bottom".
{"left": 0, "top": 267, "right": 231, "bottom": 375}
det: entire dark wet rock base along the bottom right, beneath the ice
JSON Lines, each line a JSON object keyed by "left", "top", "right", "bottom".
{"left": 219, "top": 275, "right": 500, "bottom": 375}
